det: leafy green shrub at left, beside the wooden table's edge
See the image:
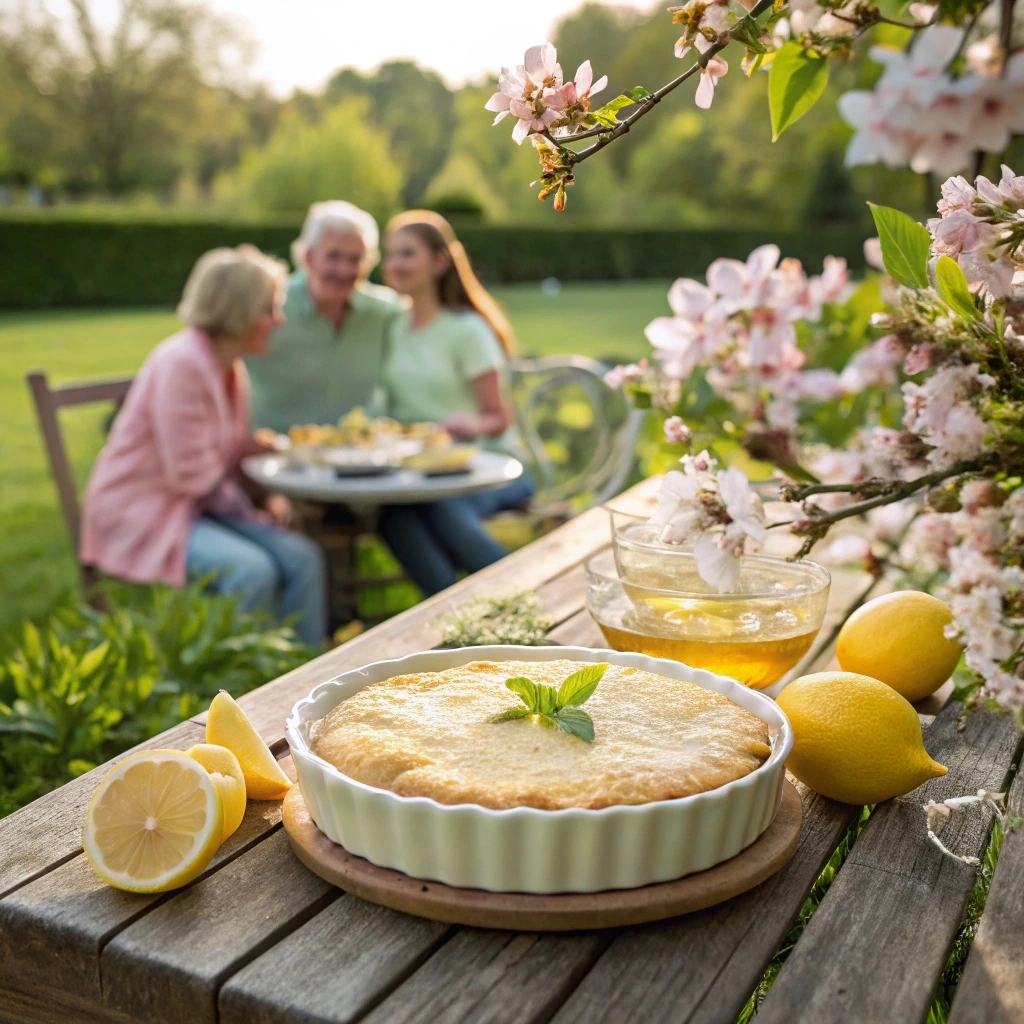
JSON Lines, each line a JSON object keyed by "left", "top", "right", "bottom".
{"left": 0, "top": 586, "right": 313, "bottom": 816}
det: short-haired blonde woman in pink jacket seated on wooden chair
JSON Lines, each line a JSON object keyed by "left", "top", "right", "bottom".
{"left": 81, "top": 246, "right": 327, "bottom": 644}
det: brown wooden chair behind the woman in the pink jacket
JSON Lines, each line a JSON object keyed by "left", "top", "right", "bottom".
{"left": 26, "top": 370, "right": 133, "bottom": 606}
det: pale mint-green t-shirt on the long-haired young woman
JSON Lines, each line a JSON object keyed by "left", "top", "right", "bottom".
{"left": 381, "top": 309, "right": 515, "bottom": 451}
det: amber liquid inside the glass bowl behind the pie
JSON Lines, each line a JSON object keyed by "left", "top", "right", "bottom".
{"left": 595, "top": 584, "right": 819, "bottom": 689}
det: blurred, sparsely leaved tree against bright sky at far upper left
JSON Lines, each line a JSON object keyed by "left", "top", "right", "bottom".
{"left": 0, "top": 0, "right": 260, "bottom": 196}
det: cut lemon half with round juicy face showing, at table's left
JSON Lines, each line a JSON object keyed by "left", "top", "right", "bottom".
{"left": 82, "top": 751, "right": 224, "bottom": 893}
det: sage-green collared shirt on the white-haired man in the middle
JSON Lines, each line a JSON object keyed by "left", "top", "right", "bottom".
{"left": 246, "top": 270, "right": 401, "bottom": 433}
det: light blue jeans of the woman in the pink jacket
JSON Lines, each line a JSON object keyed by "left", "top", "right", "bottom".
{"left": 185, "top": 516, "right": 327, "bottom": 647}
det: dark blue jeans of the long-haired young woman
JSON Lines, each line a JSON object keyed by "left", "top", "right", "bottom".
{"left": 380, "top": 477, "right": 534, "bottom": 595}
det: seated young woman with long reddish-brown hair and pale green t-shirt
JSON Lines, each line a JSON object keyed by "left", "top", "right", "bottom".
{"left": 381, "top": 210, "right": 532, "bottom": 594}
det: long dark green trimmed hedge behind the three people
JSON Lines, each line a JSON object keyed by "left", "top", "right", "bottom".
{"left": 0, "top": 215, "right": 863, "bottom": 309}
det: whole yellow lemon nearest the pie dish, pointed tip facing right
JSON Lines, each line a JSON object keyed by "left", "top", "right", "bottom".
{"left": 777, "top": 672, "right": 946, "bottom": 804}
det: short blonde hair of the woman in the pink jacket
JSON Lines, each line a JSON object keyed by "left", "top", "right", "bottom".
{"left": 178, "top": 246, "right": 288, "bottom": 338}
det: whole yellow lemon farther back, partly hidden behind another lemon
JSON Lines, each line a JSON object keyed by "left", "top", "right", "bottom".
{"left": 836, "top": 590, "right": 963, "bottom": 700}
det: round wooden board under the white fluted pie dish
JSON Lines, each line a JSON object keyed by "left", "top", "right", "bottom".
{"left": 284, "top": 781, "right": 803, "bottom": 932}
